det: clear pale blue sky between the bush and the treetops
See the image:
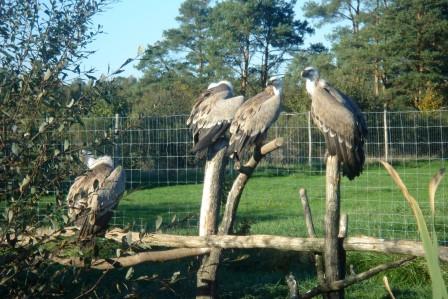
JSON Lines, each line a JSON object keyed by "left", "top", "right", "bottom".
{"left": 84, "top": 0, "right": 329, "bottom": 77}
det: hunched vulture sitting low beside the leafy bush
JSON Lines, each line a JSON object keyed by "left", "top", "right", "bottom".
{"left": 67, "top": 151, "right": 125, "bottom": 241}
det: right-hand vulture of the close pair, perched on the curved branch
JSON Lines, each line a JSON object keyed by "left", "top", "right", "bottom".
{"left": 227, "top": 76, "right": 282, "bottom": 164}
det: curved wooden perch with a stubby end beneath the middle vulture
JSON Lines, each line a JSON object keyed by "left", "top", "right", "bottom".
{"left": 196, "top": 138, "right": 283, "bottom": 299}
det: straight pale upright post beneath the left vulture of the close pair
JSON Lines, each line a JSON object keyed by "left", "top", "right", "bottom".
{"left": 196, "top": 139, "right": 227, "bottom": 298}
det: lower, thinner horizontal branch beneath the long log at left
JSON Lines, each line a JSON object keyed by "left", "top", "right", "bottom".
{"left": 52, "top": 248, "right": 210, "bottom": 270}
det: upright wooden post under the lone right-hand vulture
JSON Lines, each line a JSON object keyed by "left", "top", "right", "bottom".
{"left": 324, "top": 155, "right": 345, "bottom": 299}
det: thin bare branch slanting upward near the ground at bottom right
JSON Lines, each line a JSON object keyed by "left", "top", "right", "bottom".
{"left": 302, "top": 256, "right": 415, "bottom": 299}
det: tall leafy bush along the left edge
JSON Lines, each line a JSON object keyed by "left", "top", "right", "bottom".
{"left": 0, "top": 0, "right": 119, "bottom": 297}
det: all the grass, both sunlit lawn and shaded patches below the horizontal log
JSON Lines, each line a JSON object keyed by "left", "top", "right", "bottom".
{"left": 19, "top": 162, "right": 448, "bottom": 299}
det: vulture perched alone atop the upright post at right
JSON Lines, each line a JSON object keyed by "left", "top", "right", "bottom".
{"left": 302, "top": 67, "right": 367, "bottom": 180}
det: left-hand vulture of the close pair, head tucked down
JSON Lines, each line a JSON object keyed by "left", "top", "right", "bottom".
{"left": 187, "top": 81, "right": 244, "bottom": 159}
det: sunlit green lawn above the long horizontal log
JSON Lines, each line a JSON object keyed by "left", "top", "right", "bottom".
{"left": 117, "top": 163, "right": 448, "bottom": 243}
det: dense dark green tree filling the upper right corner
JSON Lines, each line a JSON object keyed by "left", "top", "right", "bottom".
{"left": 378, "top": 0, "right": 448, "bottom": 110}
